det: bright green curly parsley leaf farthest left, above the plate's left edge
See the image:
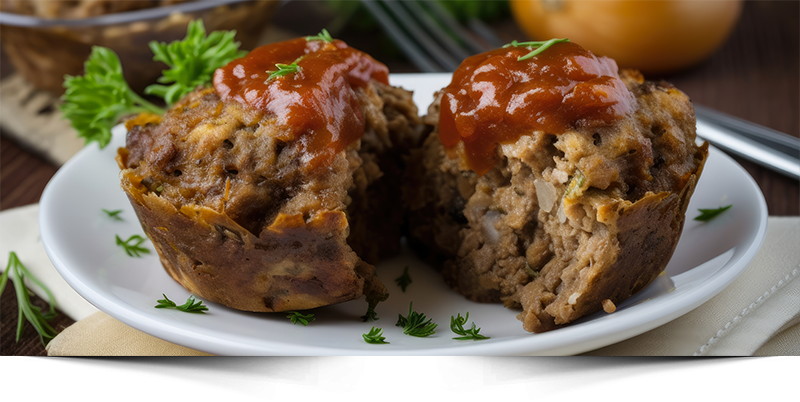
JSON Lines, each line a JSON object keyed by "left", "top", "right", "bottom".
{"left": 59, "top": 46, "right": 164, "bottom": 148}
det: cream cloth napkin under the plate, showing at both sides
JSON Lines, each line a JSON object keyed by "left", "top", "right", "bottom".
{"left": 0, "top": 204, "right": 800, "bottom": 356}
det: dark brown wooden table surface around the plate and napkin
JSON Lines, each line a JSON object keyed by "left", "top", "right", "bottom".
{"left": 0, "top": 0, "right": 800, "bottom": 356}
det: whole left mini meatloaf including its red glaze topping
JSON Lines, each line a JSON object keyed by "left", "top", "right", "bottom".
{"left": 117, "top": 38, "right": 421, "bottom": 312}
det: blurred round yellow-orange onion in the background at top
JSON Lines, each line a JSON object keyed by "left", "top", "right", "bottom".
{"left": 510, "top": 0, "right": 743, "bottom": 73}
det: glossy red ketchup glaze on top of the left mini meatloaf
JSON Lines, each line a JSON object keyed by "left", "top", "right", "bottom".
{"left": 214, "top": 38, "right": 389, "bottom": 170}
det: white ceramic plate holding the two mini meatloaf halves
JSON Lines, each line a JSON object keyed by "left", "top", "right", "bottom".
{"left": 40, "top": 74, "right": 767, "bottom": 355}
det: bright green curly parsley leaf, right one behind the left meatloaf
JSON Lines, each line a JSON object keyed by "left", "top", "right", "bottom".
{"left": 144, "top": 19, "right": 247, "bottom": 106}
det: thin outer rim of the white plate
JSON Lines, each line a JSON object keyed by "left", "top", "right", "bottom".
{"left": 39, "top": 73, "right": 768, "bottom": 355}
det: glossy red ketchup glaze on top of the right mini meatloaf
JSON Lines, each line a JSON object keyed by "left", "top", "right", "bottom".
{"left": 439, "top": 42, "right": 636, "bottom": 175}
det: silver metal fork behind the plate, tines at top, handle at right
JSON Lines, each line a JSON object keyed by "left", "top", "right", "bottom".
{"left": 361, "top": 0, "right": 800, "bottom": 180}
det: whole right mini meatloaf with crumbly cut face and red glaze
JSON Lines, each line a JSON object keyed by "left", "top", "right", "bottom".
{"left": 404, "top": 42, "right": 708, "bottom": 333}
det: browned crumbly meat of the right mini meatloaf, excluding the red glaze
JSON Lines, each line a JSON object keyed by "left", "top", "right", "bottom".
{"left": 405, "top": 71, "right": 707, "bottom": 332}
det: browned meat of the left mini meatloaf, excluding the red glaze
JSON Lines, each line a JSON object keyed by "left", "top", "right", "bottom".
{"left": 118, "top": 81, "right": 420, "bottom": 312}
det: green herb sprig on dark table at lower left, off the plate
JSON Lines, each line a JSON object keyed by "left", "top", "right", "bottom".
{"left": 0, "top": 251, "right": 58, "bottom": 345}
